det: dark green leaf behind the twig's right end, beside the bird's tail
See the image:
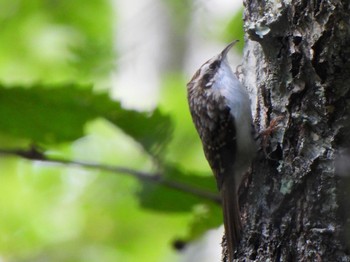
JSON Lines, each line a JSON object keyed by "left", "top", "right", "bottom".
{"left": 138, "top": 166, "right": 222, "bottom": 241}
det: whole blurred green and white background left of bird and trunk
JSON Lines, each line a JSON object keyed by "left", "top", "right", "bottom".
{"left": 0, "top": 0, "right": 243, "bottom": 262}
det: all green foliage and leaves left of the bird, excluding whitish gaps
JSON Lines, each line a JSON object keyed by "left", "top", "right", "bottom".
{"left": 0, "top": 0, "right": 243, "bottom": 262}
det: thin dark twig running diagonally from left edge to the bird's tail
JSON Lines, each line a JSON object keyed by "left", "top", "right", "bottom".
{"left": 0, "top": 146, "right": 220, "bottom": 203}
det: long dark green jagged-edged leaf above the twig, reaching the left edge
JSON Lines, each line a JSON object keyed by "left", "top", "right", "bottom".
{"left": 0, "top": 84, "right": 172, "bottom": 156}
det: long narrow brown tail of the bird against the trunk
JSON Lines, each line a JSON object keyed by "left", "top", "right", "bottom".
{"left": 220, "top": 174, "right": 241, "bottom": 262}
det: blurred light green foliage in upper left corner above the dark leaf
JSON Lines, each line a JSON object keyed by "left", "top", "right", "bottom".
{"left": 0, "top": 0, "right": 115, "bottom": 83}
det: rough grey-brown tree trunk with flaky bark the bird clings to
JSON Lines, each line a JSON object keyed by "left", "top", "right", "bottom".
{"left": 223, "top": 0, "right": 350, "bottom": 261}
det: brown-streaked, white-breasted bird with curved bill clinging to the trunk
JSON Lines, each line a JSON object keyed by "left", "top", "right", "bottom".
{"left": 187, "top": 41, "right": 256, "bottom": 261}
